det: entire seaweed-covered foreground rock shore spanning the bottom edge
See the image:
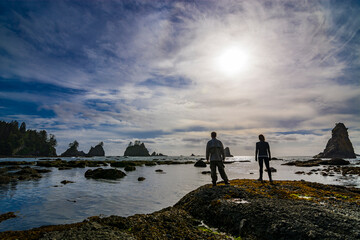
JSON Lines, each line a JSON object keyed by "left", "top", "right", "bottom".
{"left": 0, "top": 179, "right": 360, "bottom": 239}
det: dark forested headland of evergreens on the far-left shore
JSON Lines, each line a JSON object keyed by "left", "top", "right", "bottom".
{"left": 0, "top": 121, "right": 57, "bottom": 157}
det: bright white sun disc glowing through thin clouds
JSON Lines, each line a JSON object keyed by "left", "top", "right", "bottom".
{"left": 216, "top": 47, "right": 249, "bottom": 76}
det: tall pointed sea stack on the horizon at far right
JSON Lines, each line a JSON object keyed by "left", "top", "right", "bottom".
{"left": 314, "top": 123, "right": 356, "bottom": 158}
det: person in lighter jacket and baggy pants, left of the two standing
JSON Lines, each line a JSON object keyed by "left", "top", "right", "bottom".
{"left": 206, "top": 132, "right": 230, "bottom": 186}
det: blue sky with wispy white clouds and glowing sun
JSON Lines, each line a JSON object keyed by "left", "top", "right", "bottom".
{"left": 0, "top": 0, "right": 360, "bottom": 156}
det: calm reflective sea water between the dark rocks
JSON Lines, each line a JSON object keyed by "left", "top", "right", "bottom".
{"left": 0, "top": 156, "right": 360, "bottom": 231}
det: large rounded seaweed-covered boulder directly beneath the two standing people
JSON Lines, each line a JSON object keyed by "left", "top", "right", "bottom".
{"left": 175, "top": 179, "right": 360, "bottom": 240}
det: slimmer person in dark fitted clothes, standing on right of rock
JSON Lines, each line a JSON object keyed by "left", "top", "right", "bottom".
{"left": 255, "top": 134, "right": 272, "bottom": 182}
